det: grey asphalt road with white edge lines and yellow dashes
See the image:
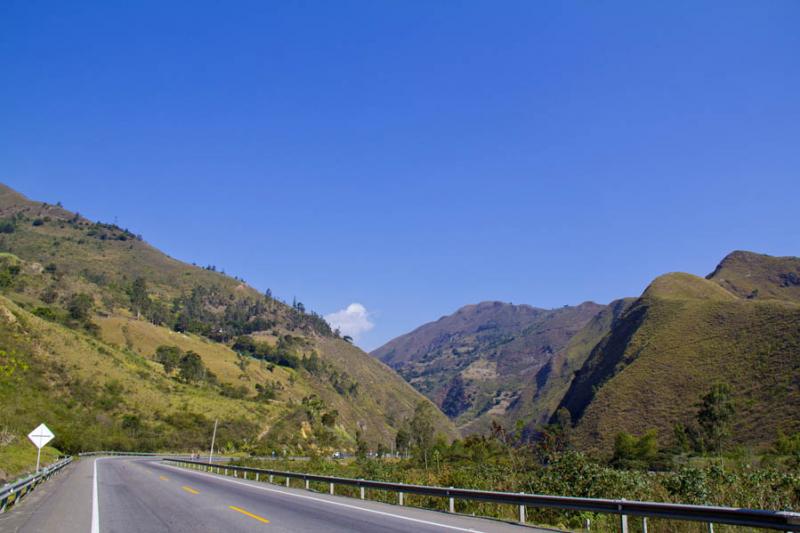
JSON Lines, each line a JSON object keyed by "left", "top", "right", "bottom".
{"left": 0, "top": 457, "right": 544, "bottom": 533}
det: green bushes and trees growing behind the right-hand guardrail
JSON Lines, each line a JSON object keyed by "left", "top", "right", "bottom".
{"left": 237, "top": 396, "right": 800, "bottom": 531}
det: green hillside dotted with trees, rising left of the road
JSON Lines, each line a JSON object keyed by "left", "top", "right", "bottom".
{"left": 0, "top": 186, "right": 454, "bottom": 470}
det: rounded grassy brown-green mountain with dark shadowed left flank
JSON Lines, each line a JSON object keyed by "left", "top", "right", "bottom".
{"left": 560, "top": 252, "right": 800, "bottom": 451}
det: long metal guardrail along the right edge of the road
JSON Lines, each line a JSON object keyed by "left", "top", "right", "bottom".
{"left": 164, "top": 459, "right": 800, "bottom": 533}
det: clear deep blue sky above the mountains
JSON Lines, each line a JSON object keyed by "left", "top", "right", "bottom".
{"left": 0, "top": 0, "right": 800, "bottom": 349}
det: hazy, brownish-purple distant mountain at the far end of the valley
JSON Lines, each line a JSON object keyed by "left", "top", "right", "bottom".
{"left": 372, "top": 302, "right": 604, "bottom": 433}
